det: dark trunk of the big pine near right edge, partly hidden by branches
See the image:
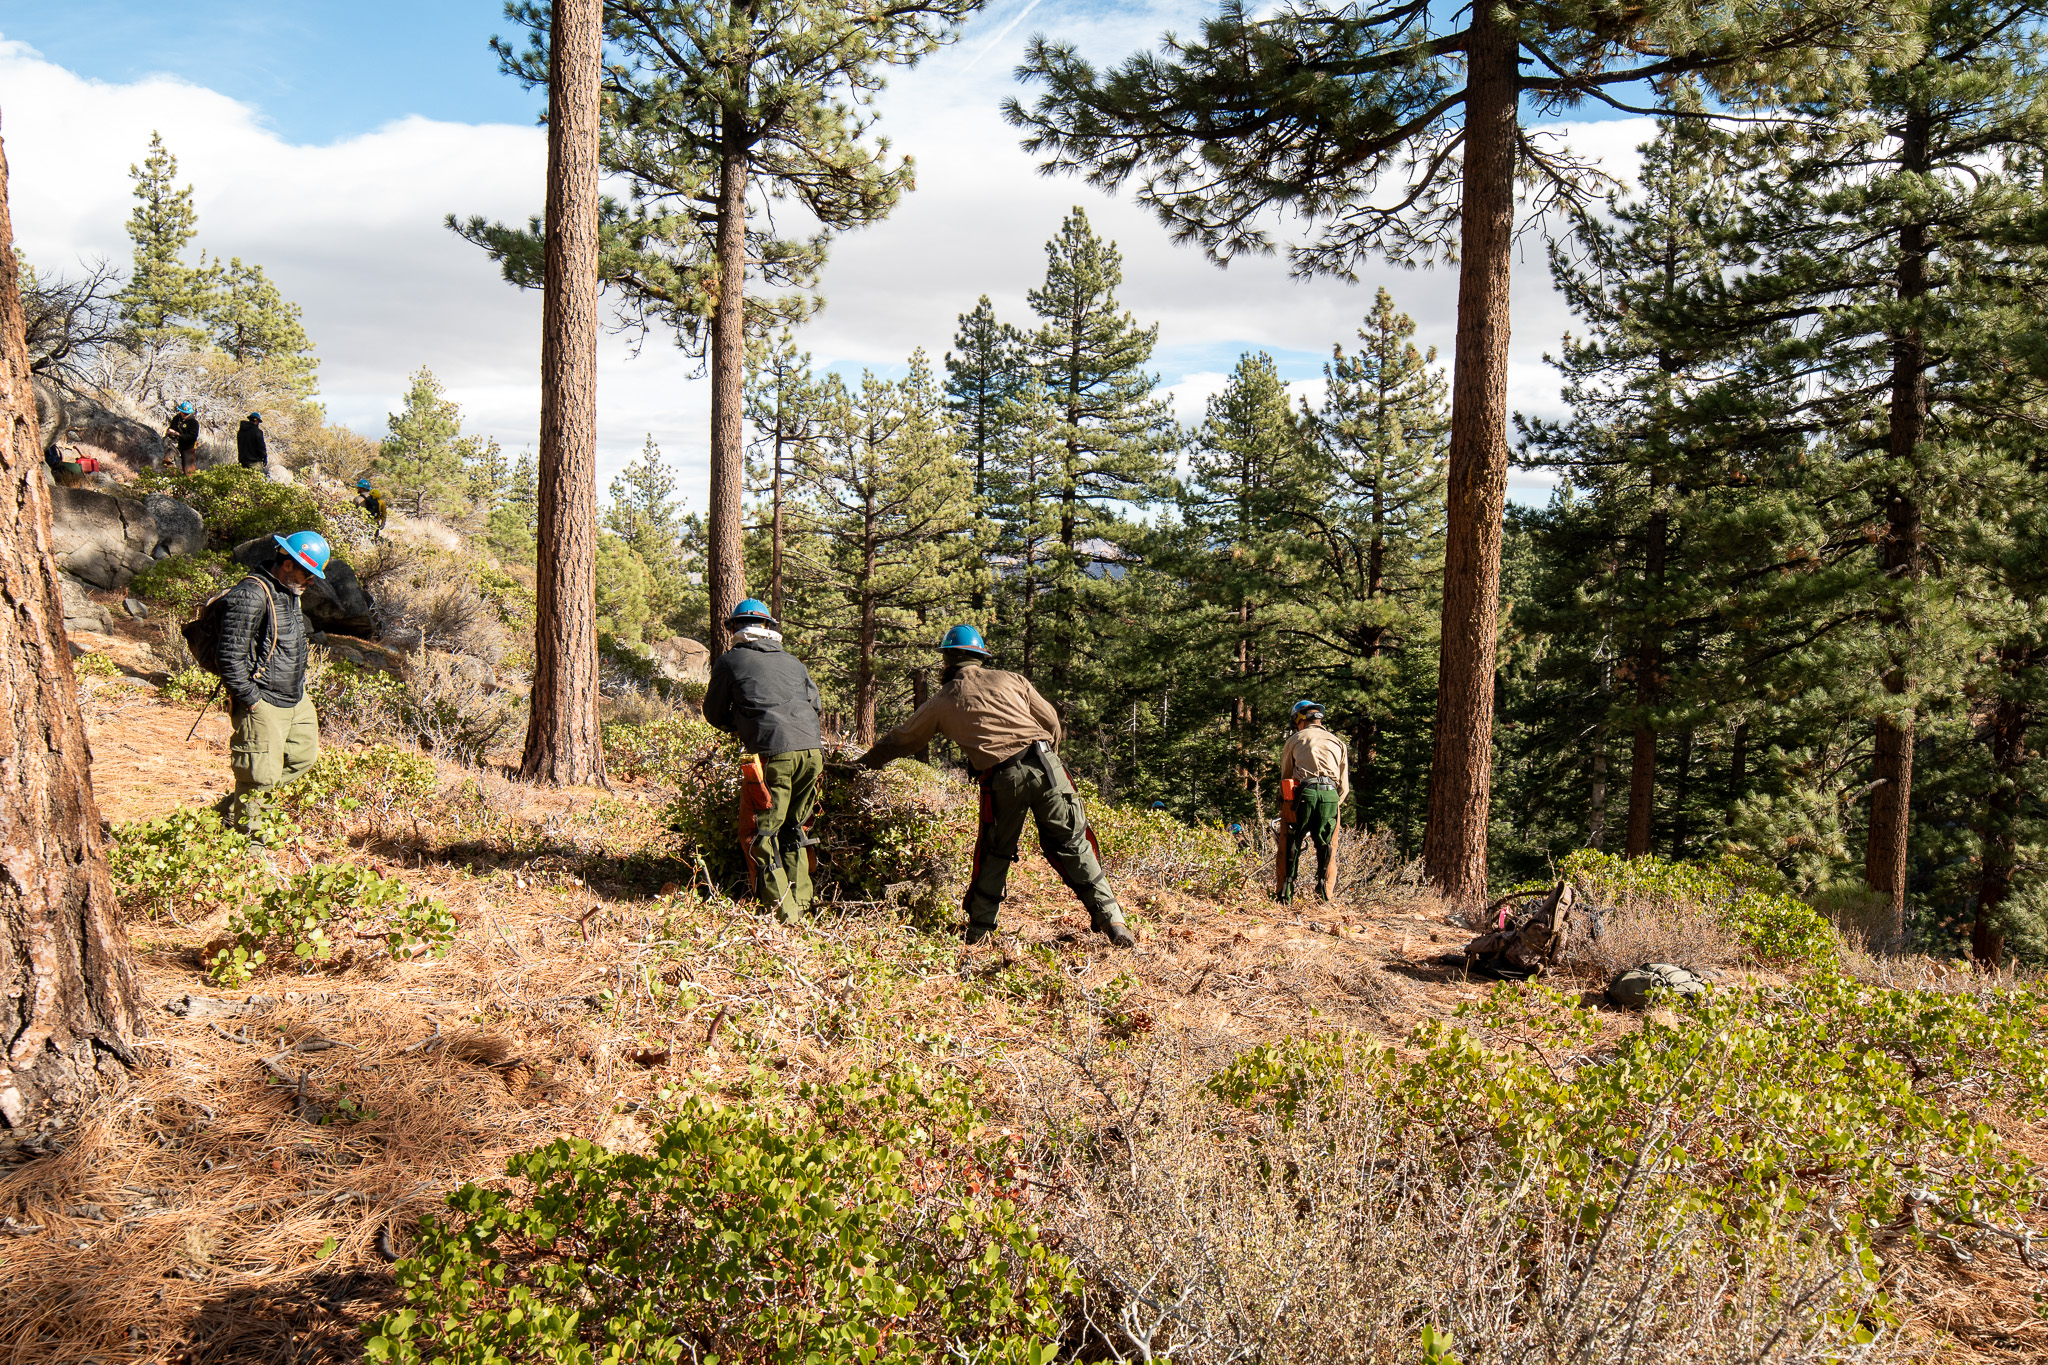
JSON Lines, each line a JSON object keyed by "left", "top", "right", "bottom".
{"left": 1864, "top": 108, "right": 1929, "bottom": 945}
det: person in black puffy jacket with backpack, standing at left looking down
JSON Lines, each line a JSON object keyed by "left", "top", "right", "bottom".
{"left": 219, "top": 530, "right": 328, "bottom": 835}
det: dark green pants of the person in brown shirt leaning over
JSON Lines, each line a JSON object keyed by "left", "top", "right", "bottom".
{"left": 967, "top": 753, "right": 1124, "bottom": 929}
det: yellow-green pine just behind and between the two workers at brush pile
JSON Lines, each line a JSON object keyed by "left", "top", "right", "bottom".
{"left": 791, "top": 352, "right": 987, "bottom": 745}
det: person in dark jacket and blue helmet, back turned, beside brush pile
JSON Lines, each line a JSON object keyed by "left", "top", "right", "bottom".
{"left": 705, "top": 598, "right": 825, "bottom": 925}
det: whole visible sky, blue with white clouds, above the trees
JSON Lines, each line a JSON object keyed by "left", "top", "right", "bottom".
{"left": 0, "top": 0, "right": 1642, "bottom": 501}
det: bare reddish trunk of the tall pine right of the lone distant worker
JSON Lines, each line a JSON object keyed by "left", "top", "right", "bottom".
{"left": 1423, "top": 4, "right": 1520, "bottom": 902}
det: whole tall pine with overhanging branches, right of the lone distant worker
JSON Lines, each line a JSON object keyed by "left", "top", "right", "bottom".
{"left": 1006, "top": 0, "right": 1913, "bottom": 900}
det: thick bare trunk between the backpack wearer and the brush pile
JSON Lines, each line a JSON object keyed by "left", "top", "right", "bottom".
{"left": 520, "top": 0, "right": 604, "bottom": 786}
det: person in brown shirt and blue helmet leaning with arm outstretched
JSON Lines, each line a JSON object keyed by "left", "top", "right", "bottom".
{"left": 860, "top": 626, "right": 1137, "bottom": 948}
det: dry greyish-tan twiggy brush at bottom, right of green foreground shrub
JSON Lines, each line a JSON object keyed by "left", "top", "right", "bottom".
{"left": 1032, "top": 1044, "right": 1913, "bottom": 1365}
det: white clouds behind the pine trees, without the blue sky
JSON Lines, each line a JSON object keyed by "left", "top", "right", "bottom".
{"left": 0, "top": 29, "right": 1645, "bottom": 515}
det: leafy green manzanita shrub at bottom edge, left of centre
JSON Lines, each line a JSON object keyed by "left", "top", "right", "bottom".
{"left": 367, "top": 1074, "right": 1077, "bottom": 1365}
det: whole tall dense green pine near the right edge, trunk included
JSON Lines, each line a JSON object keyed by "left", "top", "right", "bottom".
{"left": 1708, "top": 0, "right": 2048, "bottom": 939}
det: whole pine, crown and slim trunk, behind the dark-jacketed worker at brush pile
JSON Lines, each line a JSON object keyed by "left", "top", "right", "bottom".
{"left": 449, "top": 0, "right": 979, "bottom": 655}
